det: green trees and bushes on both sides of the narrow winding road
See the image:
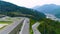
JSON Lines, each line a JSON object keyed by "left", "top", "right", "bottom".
{"left": 30, "top": 18, "right": 60, "bottom": 34}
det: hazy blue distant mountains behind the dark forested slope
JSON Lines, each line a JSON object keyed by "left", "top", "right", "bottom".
{"left": 34, "top": 4, "right": 60, "bottom": 18}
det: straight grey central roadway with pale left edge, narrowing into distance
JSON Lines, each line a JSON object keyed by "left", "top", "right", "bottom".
{"left": 19, "top": 18, "right": 29, "bottom": 34}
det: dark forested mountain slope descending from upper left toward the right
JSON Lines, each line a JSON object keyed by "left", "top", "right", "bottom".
{"left": 0, "top": 1, "right": 46, "bottom": 20}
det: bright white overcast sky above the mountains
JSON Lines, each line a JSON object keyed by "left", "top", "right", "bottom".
{"left": 4, "top": 0, "right": 60, "bottom": 8}
